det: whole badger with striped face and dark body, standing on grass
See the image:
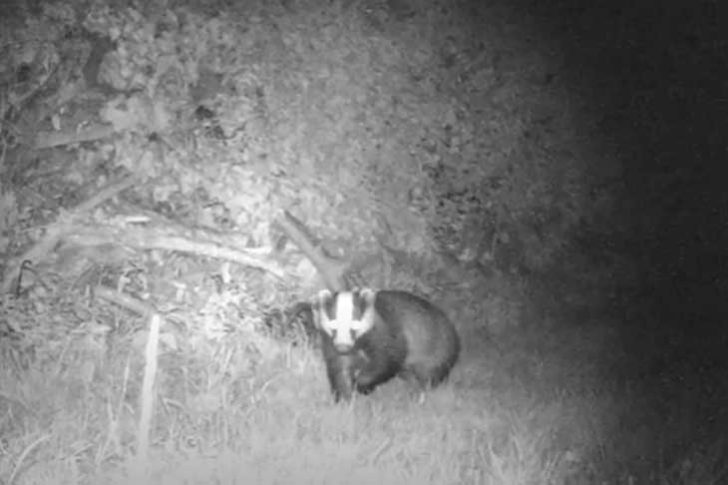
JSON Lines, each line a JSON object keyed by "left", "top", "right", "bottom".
{"left": 312, "top": 288, "right": 460, "bottom": 402}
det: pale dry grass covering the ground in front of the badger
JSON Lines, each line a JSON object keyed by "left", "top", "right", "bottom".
{"left": 0, "top": 290, "right": 725, "bottom": 485}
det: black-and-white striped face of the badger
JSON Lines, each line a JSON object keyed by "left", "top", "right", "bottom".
{"left": 314, "top": 289, "right": 375, "bottom": 353}
